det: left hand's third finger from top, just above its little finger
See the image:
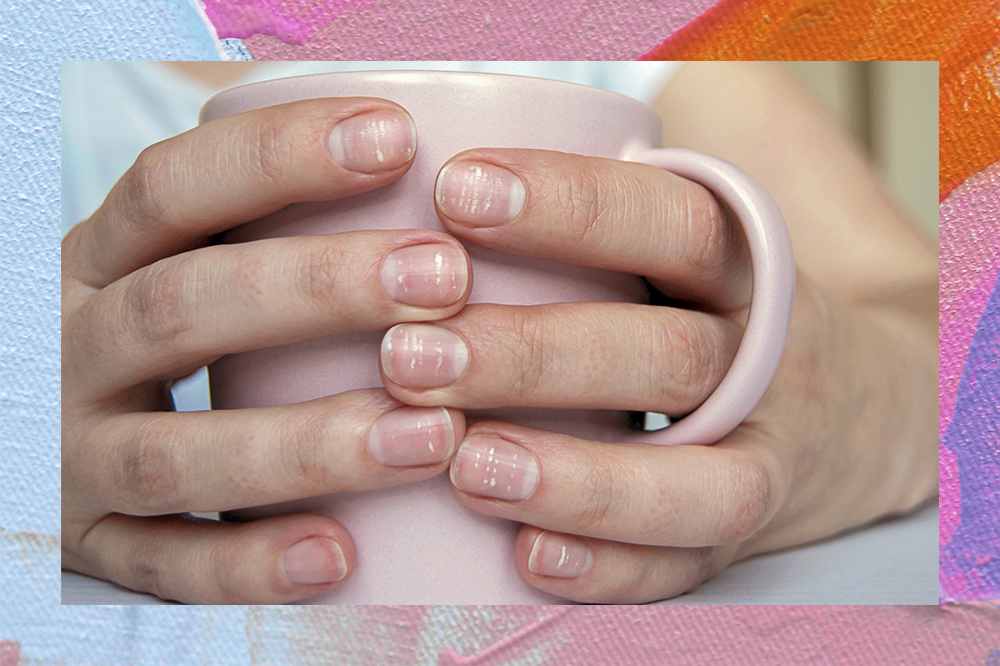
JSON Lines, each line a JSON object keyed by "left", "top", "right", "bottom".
{"left": 64, "top": 390, "right": 465, "bottom": 515}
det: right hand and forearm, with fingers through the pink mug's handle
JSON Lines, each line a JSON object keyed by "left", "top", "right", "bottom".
{"left": 382, "top": 63, "right": 937, "bottom": 603}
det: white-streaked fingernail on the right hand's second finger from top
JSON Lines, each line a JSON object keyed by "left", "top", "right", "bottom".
{"left": 382, "top": 324, "right": 469, "bottom": 388}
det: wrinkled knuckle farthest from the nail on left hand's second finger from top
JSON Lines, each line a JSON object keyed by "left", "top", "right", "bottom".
{"left": 123, "top": 257, "right": 197, "bottom": 344}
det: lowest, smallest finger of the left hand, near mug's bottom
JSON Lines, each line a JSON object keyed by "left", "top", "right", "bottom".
{"left": 63, "top": 514, "right": 357, "bottom": 604}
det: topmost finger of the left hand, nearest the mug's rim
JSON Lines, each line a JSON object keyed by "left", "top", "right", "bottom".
{"left": 63, "top": 98, "right": 416, "bottom": 287}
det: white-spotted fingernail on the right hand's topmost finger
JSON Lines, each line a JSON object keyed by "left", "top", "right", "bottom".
{"left": 434, "top": 162, "right": 525, "bottom": 227}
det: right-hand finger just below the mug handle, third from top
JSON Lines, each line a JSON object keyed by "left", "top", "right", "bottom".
{"left": 450, "top": 422, "right": 785, "bottom": 548}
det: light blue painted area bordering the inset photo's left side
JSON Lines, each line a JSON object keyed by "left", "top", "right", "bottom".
{"left": 0, "top": 0, "right": 237, "bottom": 665}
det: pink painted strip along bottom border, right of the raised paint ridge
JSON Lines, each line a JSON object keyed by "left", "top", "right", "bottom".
{"left": 438, "top": 603, "right": 1000, "bottom": 666}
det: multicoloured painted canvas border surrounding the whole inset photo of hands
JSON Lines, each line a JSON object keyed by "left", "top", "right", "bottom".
{"left": 0, "top": 0, "right": 1000, "bottom": 666}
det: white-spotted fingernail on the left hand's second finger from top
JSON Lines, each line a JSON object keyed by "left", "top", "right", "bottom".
{"left": 382, "top": 243, "right": 469, "bottom": 308}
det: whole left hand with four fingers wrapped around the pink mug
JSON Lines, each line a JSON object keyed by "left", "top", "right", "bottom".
{"left": 62, "top": 98, "right": 470, "bottom": 604}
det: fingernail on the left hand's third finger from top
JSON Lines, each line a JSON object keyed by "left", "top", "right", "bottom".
{"left": 368, "top": 407, "right": 455, "bottom": 467}
